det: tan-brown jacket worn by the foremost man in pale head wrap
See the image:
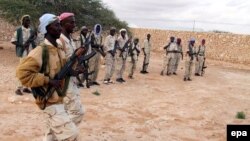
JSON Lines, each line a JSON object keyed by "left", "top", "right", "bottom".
{"left": 16, "top": 39, "right": 66, "bottom": 108}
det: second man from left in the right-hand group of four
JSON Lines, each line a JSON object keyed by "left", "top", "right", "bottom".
{"left": 173, "top": 38, "right": 183, "bottom": 75}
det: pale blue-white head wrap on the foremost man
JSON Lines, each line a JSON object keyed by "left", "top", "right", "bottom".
{"left": 39, "top": 13, "right": 58, "bottom": 35}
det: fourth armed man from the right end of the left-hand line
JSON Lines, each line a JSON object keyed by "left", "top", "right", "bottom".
{"left": 103, "top": 27, "right": 118, "bottom": 84}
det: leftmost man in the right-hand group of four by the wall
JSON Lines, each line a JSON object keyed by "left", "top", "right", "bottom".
{"left": 161, "top": 37, "right": 178, "bottom": 75}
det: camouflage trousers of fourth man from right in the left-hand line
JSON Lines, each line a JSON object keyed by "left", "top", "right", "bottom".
{"left": 104, "top": 53, "right": 115, "bottom": 80}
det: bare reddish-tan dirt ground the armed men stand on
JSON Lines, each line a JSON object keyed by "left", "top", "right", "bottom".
{"left": 0, "top": 42, "right": 250, "bottom": 141}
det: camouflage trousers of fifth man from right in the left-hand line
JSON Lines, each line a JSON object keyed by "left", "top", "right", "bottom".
{"left": 89, "top": 53, "right": 101, "bottom": 82}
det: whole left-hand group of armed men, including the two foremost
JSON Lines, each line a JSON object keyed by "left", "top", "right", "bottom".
{"left": 11, "top": 12, "right": 151, "bottom": 141}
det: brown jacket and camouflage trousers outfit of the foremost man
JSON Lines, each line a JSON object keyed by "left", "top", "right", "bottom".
{"left": 16, "top": 39, "right": 78, "bottom": 141}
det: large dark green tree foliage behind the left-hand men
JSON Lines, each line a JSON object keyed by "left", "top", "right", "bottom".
{"left": 0, "top": 0, "right": 128, "bottom": 29}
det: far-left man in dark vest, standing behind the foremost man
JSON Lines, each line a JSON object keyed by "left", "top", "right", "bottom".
{"left": 11, "top": 15, "right": 36, "bottom": 95}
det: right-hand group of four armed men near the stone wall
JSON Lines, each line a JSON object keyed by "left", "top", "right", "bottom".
{"left": 160, "top": 37, "right": 206, "bottom": 81}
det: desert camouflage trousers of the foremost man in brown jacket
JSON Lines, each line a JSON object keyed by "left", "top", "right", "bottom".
{"left": 43, "top": 104, "right": 79, "bottom": 141}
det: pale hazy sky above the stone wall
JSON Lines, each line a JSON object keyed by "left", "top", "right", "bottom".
{"left": 102, "top": 0, "right": 250, "bottom": 34}
